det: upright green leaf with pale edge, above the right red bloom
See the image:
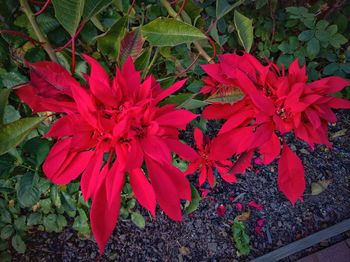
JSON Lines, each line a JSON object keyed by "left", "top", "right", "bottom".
{"left": 234, "top": 10, "right": 254, "bottom": 53}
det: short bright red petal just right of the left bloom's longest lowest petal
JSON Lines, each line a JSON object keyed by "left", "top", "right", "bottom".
{"left": 129, "top": 168, "right": 156, "bottom": 217}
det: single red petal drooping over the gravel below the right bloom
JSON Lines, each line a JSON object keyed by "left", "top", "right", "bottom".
{"left": 278, "top": 144, "right": 305, "bottom": 206}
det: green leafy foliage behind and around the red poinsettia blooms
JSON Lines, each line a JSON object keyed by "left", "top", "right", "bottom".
{"left": 0, "top": 0, "right": 350, "bottom": 256}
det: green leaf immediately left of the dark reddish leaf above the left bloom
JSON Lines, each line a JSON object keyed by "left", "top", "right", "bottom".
{"left": 96, "top": 17, "right": 128, "bottom": 60}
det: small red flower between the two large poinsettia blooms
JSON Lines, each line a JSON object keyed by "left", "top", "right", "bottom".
{"left": 186, "top": 128, "right": 237, "bottom": 187}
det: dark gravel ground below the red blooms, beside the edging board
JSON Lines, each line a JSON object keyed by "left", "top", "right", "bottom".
{"left": 14, "top": 111, "right": 350, "bottom": 261}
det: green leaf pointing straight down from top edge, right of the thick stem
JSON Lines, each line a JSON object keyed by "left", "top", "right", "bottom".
{"left": 52, "top": 0, "right": 85, "bottom": 36}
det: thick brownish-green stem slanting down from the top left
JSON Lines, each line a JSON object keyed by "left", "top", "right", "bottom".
{"left": 19, "top": 0, "right": 58, "bottom": 63}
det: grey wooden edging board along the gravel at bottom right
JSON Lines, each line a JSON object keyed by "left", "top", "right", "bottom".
{"left": 251, "top": 219, "right": 350, "bottom": 262}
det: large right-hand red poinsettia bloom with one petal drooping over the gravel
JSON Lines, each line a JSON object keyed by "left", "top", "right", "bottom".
{"left": 202, "top": 53, "right": 350, "bottom": 205}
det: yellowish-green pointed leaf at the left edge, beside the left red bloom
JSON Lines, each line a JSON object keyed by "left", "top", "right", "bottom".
{"left": 0, "top": 117, "right": 44, "bottom": 155}
